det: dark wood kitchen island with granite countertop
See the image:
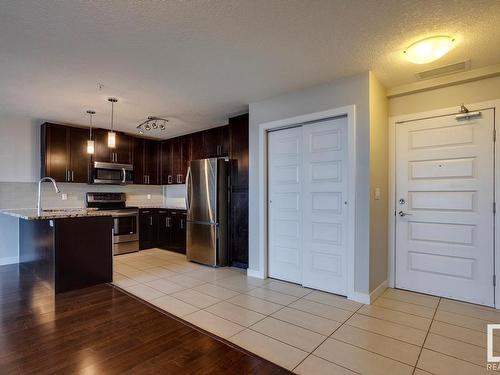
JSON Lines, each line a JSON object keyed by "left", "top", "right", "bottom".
{"left": 1, "top": 209, "right": 113, "bottom": 294}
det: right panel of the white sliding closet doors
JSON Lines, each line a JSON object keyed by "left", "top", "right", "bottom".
{"left": 302, "top": 117, "right": 348, "bottom": 295}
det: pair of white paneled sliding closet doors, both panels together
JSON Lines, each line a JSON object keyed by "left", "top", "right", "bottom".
{"left": 268, "top": 117, "right": 349, "bottom": 295}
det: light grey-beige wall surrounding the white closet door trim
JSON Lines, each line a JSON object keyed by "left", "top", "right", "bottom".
{"left": 249, "top": 72, "right": 370, "bottom": 293}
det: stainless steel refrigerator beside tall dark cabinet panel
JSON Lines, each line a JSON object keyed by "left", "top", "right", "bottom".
{"left": 186, "top": 158, "right": 229, "bottom": 267}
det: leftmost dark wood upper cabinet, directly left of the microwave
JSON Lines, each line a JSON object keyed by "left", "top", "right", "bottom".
{"left": 41, "top": 123, "right": 89, "bottom": 183}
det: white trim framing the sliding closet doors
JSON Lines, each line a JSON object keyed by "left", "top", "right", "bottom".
{"left": 256, "top": 105, "right": 357, "bottom": 300}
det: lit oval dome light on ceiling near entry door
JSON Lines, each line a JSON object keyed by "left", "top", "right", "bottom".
{"left": 403, "top": 35, "right": 455, "bottom": 64}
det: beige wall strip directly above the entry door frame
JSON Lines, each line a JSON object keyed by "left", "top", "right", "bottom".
{"left": 389, "top": 76, "right": 500, "bottom": 116}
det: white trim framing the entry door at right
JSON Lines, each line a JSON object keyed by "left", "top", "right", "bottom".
{"left": 387, "top": 100, "right": 500, "bottom": 309}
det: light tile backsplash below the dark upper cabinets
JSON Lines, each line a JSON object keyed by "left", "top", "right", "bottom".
{"left": 0, "top": 182, "right": 164, "bottom": 209}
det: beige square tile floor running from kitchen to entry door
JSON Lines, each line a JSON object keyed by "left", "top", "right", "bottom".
{"left": 114, "top": 249, "right": 500, "bottom": 375}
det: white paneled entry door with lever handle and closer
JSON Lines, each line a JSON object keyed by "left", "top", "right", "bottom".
{"left": 395, "top": 109, "right": 494, "bottom": 306}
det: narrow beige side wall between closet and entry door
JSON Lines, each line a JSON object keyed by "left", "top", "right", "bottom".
{"left": 369, "top": 72, "right": 389, "bottom": 292}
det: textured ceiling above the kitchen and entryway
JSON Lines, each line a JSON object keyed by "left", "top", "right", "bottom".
{"left": 0, "top": 0, "right": 500, "bottom": 137}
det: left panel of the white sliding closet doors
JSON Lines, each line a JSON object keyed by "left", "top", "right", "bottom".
{"left": 268, "top": 127, "right": 302, "bottom": 283}
